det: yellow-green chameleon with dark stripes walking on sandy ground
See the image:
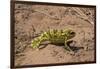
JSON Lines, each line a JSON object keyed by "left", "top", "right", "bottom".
{"left": 32, "top": 29, "right": 75, "bottom": 52}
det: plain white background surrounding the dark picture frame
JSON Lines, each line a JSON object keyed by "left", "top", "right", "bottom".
{"left": 0, "top": 0, "right": 100, "bottom": 69}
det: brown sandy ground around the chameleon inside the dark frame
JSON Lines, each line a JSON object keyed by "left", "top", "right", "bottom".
{"left": 15, "top": 4, "right": 95, "bottom": 66}
